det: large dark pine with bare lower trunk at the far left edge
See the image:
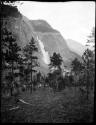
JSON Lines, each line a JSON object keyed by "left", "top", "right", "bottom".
{"left": 1, "top": 27, "right": 21, "bottom": 94}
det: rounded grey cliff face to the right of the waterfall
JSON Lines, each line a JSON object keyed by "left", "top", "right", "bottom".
{"left": 31, "top": 20, "right": 80, "bottom": 66}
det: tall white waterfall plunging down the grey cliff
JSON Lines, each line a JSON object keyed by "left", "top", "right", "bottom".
{"left": 37, "top": 36, "right": 50, "bottom": 65}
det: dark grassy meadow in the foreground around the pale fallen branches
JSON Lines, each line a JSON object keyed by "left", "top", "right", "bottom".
{"left": 1, "top": 87, "right": 94, "bottom": 123}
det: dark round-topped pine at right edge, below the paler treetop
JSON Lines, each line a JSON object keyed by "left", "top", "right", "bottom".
{"left": 82, "top": 49, "right": 95, "bottom": 99}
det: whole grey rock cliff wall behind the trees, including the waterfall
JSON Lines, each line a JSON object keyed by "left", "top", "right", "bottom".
{"left": 3, "top": 4, "right": 80, "bottom": 73}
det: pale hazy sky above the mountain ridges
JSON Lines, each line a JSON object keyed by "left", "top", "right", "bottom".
{"left": 18, "top": 1, "right": 95, "bottom": 45}
